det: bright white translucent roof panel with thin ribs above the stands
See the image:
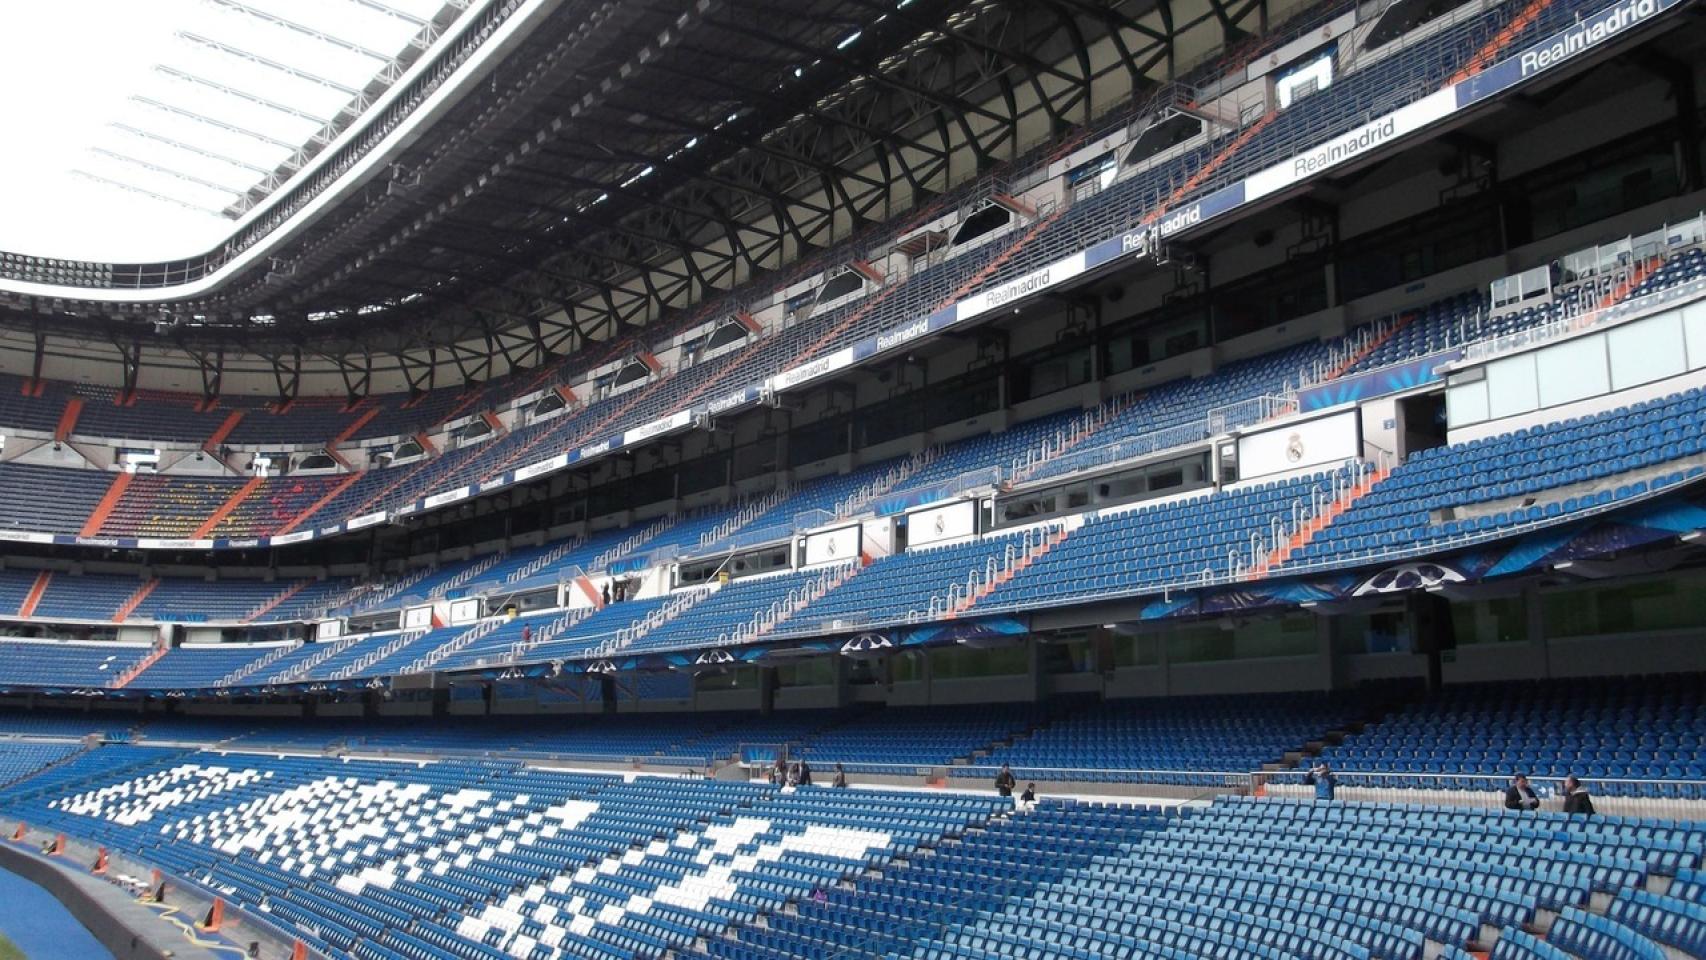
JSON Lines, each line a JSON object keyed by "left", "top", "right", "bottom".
{"left": 0, "top": 0, "right": 464, "bottom": 263}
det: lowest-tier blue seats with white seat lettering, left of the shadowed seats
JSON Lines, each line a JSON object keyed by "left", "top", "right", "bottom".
{"left": 0, "top": 747, "right": 1000, "bottom": 957}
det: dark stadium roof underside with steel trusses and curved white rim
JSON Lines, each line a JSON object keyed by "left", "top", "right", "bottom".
{"left": 0, "top": 0, "right": 1255, "bottom": 379}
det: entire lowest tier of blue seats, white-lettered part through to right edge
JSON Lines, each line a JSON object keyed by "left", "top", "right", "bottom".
{"left": 0, "top": 747, "right": 1706, "bottom": 960}
